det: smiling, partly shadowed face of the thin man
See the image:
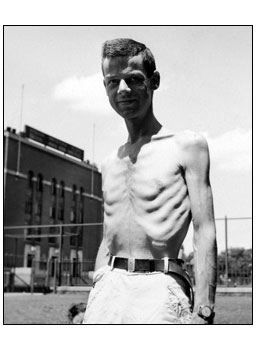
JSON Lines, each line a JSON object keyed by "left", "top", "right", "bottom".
{"left": 103, "top": 55, "right": 157, "bottom": 120}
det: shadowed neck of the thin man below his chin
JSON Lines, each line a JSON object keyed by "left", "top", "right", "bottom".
{"left": 125, "top": 111, "right": 162, "bottom": 143}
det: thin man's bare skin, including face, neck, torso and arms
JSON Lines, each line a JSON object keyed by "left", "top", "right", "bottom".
{"left": 90, "top": 43, "right": 217, "bottom": 324}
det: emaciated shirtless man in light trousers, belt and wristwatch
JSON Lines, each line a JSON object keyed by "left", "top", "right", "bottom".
{"left": 84, "top": 39, "right": 217, "bottom": 324}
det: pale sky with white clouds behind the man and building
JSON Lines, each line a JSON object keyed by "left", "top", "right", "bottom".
{"left": 4, "top": 26, "right": 252, "bottom": 253}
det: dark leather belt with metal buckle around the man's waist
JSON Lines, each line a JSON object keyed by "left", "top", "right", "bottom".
{"left": 108, "top": 255, "right": 194, "bottom": 310}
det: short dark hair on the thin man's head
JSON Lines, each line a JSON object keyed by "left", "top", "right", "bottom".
{"left": 102, "top": 38, "right": 156, "bottom": 78}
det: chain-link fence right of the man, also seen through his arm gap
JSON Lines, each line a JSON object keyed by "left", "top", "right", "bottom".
{"left": 184, "top": 216, "right": 252, "bottom": 287}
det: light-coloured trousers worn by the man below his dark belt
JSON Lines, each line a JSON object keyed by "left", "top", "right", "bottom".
{"left": 83, "top": 266, "right": 192, "bottom": 324}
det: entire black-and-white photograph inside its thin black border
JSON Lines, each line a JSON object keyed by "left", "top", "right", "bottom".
{"left": 3, "top": 25, "right": 253, "bottom": 335}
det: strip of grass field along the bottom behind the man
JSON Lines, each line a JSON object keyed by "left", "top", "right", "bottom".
{"left": 4, "top": 293, "right": 252, "bottom": 324}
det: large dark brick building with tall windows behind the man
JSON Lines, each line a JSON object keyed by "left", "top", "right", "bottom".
{"left": 4, "top": 126, "right": 102, "bottom": 278}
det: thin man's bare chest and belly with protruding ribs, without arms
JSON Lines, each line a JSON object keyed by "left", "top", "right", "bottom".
{"left": 102, "top": 128, "right": 191, "bottom": 258}
